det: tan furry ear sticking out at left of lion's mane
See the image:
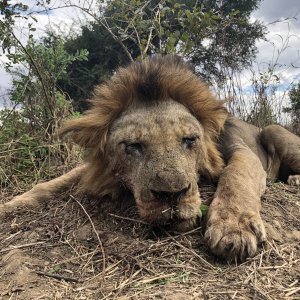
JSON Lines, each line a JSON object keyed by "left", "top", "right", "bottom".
{"left": 59, "top": 114, "right": 107, "bottom": 148}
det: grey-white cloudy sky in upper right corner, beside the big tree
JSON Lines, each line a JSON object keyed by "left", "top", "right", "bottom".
{"left": 252, "top": 0, "right": 300, "bottom": 87}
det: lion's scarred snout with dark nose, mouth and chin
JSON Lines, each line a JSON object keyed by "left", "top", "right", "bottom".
{"left": 126, "top": 149, "right": 201, "bottom": 230}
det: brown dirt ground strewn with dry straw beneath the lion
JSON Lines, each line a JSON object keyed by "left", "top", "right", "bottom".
{"left": 0, "top": 183, "right": 300, "bottom": 300}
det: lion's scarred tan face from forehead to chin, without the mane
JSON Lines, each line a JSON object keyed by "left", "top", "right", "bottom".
{"left": 107, "top": 100, "right": 207, "bottom": 224}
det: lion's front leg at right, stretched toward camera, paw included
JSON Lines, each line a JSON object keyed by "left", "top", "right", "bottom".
{"left": 205, "top": 148, "right": 266, "bottom": 260}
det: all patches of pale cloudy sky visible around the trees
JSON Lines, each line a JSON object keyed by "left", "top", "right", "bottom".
{"left": 0, "top": 0, "right": 300, "bottom": 108}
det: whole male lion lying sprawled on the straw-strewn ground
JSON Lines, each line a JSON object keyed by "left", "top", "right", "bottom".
{"left": 0, "top": 56, "right": 300, "bottom": 260}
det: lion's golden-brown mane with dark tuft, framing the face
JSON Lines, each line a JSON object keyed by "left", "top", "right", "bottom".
{"left": 61, "top": 55, "right": 227, "bottom": 197}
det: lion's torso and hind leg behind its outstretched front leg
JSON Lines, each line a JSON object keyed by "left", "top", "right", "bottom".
{"left": 220, "top": 117, "right": 300, "bottom": 182}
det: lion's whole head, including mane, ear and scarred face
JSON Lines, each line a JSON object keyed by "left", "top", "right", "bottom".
{"left": 63, "top": 56, "right": 227, "bottom": 230}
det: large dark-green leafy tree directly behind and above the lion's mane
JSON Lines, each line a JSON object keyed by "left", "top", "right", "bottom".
{"left": 60, "top": 0, "right": 265, "bottom": 110}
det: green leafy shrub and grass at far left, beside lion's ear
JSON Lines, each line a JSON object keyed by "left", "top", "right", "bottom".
{"left": 0, "top": 5, "right": 88, "bottom": 188}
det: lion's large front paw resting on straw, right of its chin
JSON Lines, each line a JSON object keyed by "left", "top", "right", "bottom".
{"left": 205, "top": 214, "right": 266, "bottom": 261}
